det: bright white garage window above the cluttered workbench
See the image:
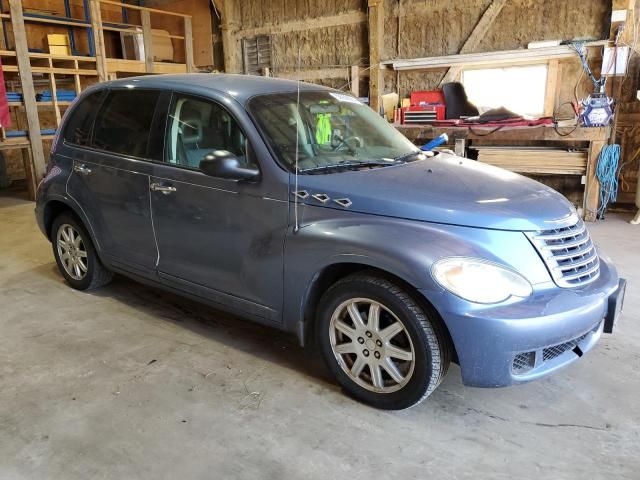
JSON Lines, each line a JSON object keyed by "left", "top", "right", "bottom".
{"left": 462, "top": 65, "right": 547, "bottom": 117}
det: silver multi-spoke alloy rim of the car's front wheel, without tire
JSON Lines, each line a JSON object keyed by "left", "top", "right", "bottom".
{"left": 329, "top": 298, "right": 415, "bottom": 393}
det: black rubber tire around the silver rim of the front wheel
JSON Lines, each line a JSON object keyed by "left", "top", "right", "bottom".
{"left": 316, "top": 272, "right": 451, "bottom": 410}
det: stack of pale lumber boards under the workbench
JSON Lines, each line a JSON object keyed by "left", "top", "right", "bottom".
{"left": 470, "top": 146, "right": 587, "bottom": 175}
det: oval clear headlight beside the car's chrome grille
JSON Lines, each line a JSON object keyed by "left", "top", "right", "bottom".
{"left": 431, "top": 257, "right": 533, "bottom": 303}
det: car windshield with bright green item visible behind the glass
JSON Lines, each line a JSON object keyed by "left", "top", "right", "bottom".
{"left": 249, "top": 91, "right": 423, "bottom": 173}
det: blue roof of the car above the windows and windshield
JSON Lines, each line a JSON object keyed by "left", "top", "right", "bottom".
{"left": 100, "top": 73, "right": 333, "bottom": 104}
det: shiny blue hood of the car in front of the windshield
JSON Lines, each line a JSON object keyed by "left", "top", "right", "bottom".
{"left": 297, "top": 153, "right": 577, "bottom": 231}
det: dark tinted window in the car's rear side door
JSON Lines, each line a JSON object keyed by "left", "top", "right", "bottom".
{"left": 92, "top": 90, "right": 160, "bottom": 157}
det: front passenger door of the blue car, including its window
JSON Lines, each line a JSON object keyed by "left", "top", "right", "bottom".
{"left": 151, "top": 94, "right": 288, "bottom": 322}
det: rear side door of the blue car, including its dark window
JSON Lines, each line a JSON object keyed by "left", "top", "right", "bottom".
{"left": 65, "top": 89, "right": 168, "bottom": 273}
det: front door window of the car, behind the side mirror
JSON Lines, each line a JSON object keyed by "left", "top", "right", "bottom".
{"left": 166, "top": 94, "right": 255, "bottom": 169}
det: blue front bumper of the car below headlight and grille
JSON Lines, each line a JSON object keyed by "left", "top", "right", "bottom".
{"left": 424, "top": 257, "right": 619, "bottom": 387}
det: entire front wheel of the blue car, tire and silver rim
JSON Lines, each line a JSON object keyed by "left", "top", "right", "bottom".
{"left": 317, "top": 274, "right": 450, "bottom": 410}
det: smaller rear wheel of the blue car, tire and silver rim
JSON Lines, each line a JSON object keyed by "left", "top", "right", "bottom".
{"left": 51, "top": 213, "right": 113, "bottom": 290}
